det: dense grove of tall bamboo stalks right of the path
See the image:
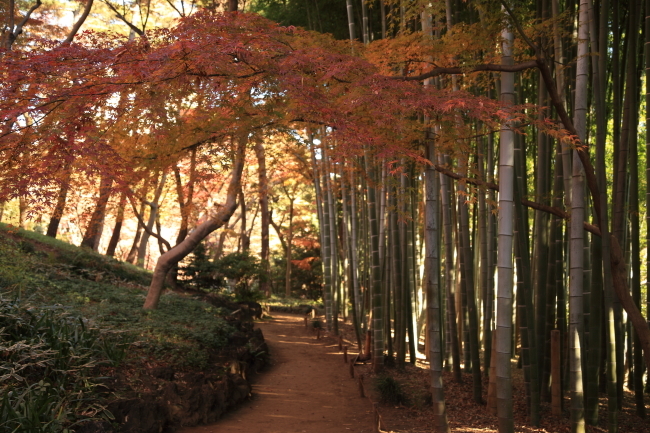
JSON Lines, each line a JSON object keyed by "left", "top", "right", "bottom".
{"left": 310, "top": 0, "right": 650, "bottom": 431}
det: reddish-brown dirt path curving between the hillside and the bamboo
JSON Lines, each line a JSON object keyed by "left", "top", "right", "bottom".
{"left": 181, "top": 313, "right": 373, "bottom": 433}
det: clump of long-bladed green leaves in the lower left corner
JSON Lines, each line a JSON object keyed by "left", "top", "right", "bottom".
{"left": 0, "top": 298, "right": 117, "bottom": 432}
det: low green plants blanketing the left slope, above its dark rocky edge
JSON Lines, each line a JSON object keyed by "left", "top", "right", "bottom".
{"left": 0, "top": 225, "right": 251, "bottom": 432}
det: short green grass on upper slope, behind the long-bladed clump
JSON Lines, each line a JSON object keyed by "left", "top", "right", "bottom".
{"left": 0, "top": 224, "right": 234, "bottom": 368}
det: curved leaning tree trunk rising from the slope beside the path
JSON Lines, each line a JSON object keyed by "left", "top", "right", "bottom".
{"left": 142, "top": 138, "right": 246, "bottom": 310}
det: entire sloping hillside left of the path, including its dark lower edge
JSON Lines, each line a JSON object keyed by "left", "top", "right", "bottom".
{"left": 0, "top": 224, "right": 267, "bottom": 432}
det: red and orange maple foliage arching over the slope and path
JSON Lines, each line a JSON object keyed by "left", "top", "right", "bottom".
{"left": 0, "top": 11, "right": 503, "bottom": 204}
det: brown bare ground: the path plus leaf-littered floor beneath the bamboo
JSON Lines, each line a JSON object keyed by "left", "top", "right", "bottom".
{"left": 181, "top": 313, "right": 650, "bottom": 433}
